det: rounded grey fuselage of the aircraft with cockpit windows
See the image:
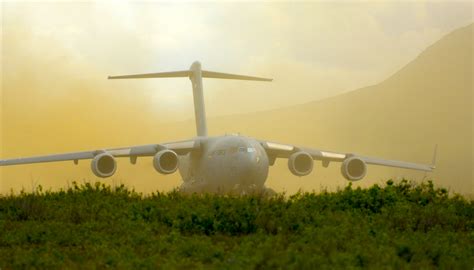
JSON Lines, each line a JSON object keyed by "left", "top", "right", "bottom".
{"left": 179, "top": 135, "right": 269, "bottom": 192}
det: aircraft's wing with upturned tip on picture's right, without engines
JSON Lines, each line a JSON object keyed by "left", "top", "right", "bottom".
{"left": 260, "top": 141, "right": 436, "bottom": 172}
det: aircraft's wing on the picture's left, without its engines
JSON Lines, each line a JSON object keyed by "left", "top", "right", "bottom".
{"left": 0, "top": 139, "right": 201, "bottom": 166}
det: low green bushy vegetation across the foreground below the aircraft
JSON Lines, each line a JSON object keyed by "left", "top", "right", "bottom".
{"left": 0, "top": 181, "right": 474, "bottom": 269}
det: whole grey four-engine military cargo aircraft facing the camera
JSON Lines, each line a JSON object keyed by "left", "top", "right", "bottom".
{"left": 0, "top": 61, "right": 436, "bottom": 193}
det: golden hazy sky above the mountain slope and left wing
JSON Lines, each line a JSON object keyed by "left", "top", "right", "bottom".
{"left": 0, "top": 1, "right": 473, "bottom": 193}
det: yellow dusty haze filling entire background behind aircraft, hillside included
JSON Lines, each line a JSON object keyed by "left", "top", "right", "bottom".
{"left": 0, "top": 2, "right": 474, "bottom": 193}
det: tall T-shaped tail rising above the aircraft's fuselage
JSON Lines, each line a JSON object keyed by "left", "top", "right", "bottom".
{"left": 109, "top": 61, "right": 272, "bottom": 136}
